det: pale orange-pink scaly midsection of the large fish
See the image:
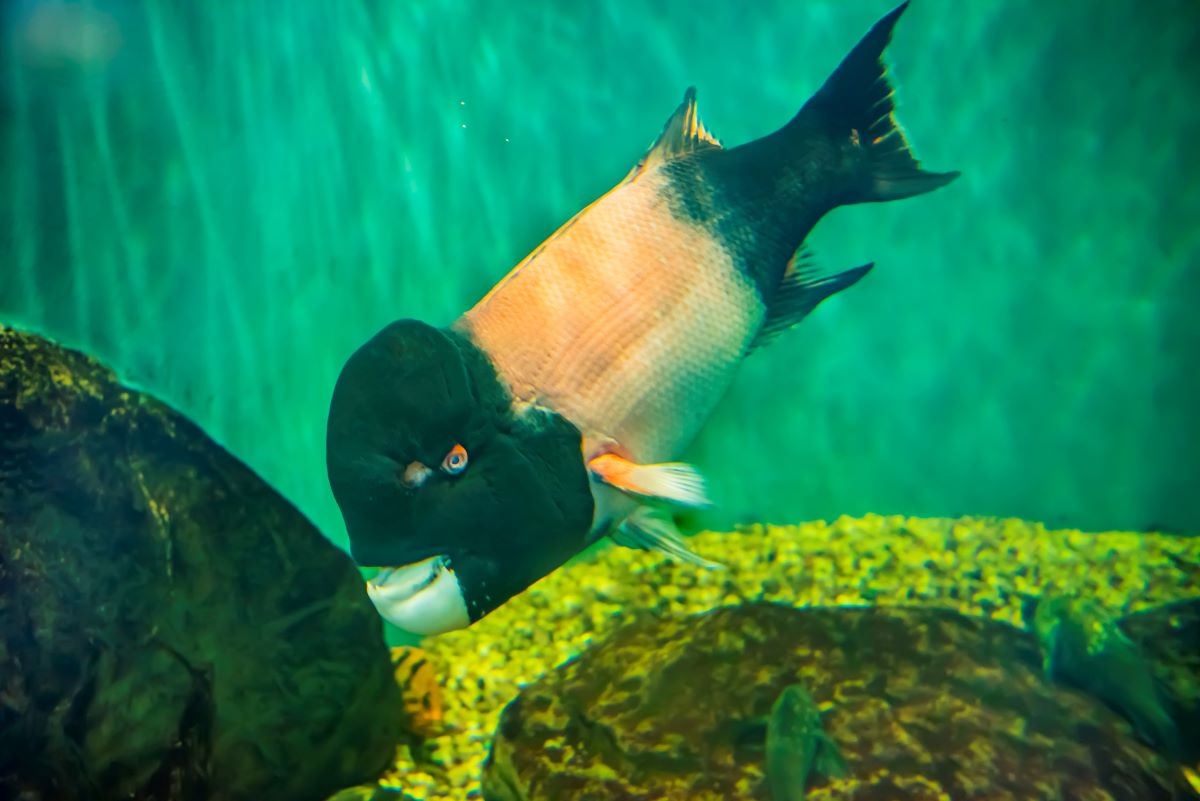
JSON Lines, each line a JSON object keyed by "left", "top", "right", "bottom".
{"left": 460, "top": 169, "right": 764, "bottom": 462}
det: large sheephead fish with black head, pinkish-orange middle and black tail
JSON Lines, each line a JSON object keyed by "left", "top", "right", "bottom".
{"left": 328, "top": 4, "right": 958, "bottom": 634}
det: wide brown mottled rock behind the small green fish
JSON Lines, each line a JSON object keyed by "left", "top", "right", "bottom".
{"left": 484, "top": 603, "right": 1183, "bottom": 801}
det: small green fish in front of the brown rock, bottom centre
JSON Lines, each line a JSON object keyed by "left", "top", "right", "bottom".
{"left": 767, "top": 685, "right": 846, "bottom": 801}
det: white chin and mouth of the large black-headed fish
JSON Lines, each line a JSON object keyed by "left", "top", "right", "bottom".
{"left": 367, "top": 554, "right": 470, "bottom": 634}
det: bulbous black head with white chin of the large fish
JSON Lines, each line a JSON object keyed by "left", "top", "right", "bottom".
{"left": 326, "top": 320, "right": 593, "bottom": 634}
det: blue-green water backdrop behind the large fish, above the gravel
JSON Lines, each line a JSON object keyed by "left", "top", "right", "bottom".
{"left": 0, "top": 0, "right": 1200, "bottom": 551}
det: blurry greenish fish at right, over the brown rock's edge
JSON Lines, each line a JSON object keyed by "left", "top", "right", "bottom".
{"left": 1033, "top": 592, "right": 1182, "bottom": 759}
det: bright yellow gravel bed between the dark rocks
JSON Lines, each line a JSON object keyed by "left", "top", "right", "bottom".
{"left": 374, "top": 516, "right": 1200, "bottom": 801}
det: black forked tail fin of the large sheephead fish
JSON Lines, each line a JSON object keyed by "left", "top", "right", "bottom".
{"left": 788, "top": 0, "right": 959, "bottom": 203}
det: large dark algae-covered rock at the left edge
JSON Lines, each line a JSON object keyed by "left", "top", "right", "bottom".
{"left": 0, "top": 327, "right": 402, "bottom": 801}
